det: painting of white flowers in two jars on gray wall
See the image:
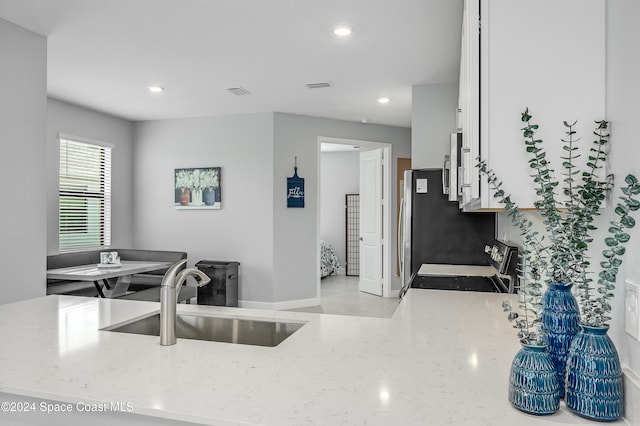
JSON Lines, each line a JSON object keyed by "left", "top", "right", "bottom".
{"left": 174, "top": 167, "right": 222, "bottom": 209}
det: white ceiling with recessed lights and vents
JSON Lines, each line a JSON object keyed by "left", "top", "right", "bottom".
{"left": 0, "top": 0, "right": 462, "bottom": 127}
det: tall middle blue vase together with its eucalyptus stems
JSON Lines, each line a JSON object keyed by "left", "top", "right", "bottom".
{"left": 478, "top": 110, "right": 588, "bottom": 397}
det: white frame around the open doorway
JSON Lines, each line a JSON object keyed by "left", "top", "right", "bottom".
{"left": 316, "top": 136, "right": 397, "bottom": 300}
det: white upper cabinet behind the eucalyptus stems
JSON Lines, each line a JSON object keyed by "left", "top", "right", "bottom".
{"left": 459, "top": 0, "right": 605, "bottom": 210}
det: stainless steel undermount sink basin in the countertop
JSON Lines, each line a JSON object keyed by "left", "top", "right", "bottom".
{"left": 101, "top": 313, "right": 305, "bottom": 347}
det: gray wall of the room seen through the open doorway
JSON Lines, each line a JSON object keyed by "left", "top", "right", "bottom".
{"left": 320, "top": 151, "right": 360, "bottom": 268}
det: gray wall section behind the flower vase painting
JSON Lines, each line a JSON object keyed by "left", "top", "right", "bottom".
{"left": 133, "top": 113, "right": 280, "bottom": 302}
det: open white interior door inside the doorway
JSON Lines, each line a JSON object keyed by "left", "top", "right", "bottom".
{"left": 358, "top": 149, "right": 383, "bottom": 296}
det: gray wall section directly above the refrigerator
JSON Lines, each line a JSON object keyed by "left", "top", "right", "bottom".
{"left": 411, "top": 82, "right": 458, "bottom": 169}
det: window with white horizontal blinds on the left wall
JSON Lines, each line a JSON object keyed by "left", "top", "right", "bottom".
{"left": 58, "top": 137, "right": 111, "bottom": 252}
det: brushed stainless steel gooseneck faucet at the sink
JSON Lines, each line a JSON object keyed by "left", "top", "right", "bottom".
{"left": 160, "top": 259, "right": 211, "bottom": 346}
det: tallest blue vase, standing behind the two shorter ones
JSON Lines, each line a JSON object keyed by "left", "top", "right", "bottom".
{"left": 542, "top": 282, "right": 580, "bottom": 398}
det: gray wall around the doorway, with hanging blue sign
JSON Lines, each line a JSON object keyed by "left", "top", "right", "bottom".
{"left": 273, "top": 113, "right": 411, "bottom": 302}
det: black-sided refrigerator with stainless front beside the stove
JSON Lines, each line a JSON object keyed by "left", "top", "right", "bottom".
{"left": 398, "top": 169, "right": 496, "bottom": 288}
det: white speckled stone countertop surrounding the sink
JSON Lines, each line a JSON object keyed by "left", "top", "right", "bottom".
{"left": 0, "top": 289, "right": 623, "bottom": 426}
